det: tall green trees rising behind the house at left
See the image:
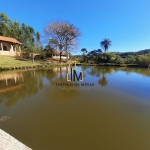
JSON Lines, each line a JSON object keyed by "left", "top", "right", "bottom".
{"left": 0, "top": 13, "right": 41, "bottom": 51}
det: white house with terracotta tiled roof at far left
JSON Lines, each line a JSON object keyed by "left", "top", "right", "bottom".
{"left": 0, "top": 36, "right": 22, "bottom": 56}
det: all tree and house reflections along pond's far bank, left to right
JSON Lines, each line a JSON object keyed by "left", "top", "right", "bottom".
{"left": 0, "top": 66, "right": 150, "bottom": 107}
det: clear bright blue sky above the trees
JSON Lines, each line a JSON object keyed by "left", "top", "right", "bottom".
{"left": 0, "top": 0, "right": 150, "bottom": 54}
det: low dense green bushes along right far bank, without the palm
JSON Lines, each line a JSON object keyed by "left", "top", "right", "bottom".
{"left": 79, "top": 50, "right": 150, "bottom": 65}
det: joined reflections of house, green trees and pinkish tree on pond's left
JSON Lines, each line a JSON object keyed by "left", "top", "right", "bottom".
{"left": 0, "top": 67, "right": 79, "bottom": 107}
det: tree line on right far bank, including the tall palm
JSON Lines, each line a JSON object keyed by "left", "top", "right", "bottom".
{"left": 77, "top": 38, "right": 150, "bottom": 65}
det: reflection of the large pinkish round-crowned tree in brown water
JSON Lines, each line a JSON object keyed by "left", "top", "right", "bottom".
{"left": 45, "top": 67, "right": 80, "bottom": 102}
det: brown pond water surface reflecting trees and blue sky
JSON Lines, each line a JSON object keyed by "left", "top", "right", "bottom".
{"left": 0, "top": 66, "right": 150, "bottom": 150}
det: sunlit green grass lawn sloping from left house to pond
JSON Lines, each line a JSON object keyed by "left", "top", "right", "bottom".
{"left": 0, "top": 56, "right": 42, "bottom": 68}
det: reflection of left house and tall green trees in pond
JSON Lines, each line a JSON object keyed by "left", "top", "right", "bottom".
{"left": 0, "top": 70, "right": 43, "bottom": 107}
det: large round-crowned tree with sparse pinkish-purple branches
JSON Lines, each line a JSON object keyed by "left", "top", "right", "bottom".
{"left": 44, "top": 21, "right": 81, "bottom": 63}
